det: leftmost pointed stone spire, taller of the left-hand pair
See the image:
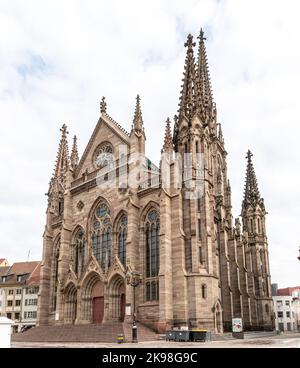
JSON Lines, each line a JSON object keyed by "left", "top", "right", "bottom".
{"left": 54, "top": 124, "right": 69, "bottom": 182}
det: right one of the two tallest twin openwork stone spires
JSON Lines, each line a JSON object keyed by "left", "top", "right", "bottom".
{"left": 197, "top": 28, "right": 213, "bottom": 113}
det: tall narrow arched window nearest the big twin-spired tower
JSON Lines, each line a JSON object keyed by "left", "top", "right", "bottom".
{"left": 146, "top": 210, "right": 160, "bottom": 301}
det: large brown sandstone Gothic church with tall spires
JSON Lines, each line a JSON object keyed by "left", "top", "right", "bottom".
{"left": 38, "top": 30, "right": 273, "bottom": 333}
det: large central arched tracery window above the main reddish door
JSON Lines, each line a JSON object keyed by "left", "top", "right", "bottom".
{"left": 92, "top": 202, "right": 111, "bottom": 271}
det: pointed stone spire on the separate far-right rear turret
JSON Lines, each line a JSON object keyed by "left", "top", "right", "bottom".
{"left": 242, "top": 150, "right": 264, "bottom": 213}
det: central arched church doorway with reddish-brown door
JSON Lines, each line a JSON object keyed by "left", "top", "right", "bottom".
{"left": 81, "top": 272, "right": 104, "bottom": 323}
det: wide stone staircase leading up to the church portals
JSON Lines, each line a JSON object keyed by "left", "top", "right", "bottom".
{"left": 12, "top": 322, "right": 159, "bottom": 343}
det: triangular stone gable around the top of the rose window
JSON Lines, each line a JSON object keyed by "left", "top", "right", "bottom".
{"left": 75, "top": 114, "right": 130, "bottom": 178}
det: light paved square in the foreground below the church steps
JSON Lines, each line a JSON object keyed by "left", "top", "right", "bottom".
{"left": 12, "top": 334, "right": 300, "bottom": 349}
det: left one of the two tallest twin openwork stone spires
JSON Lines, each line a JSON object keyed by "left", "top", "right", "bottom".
{"left": 179, "top": 34, "right": 197, "bottom": 121}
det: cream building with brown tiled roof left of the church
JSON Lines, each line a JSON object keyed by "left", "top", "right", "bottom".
{"left": 0, "top": 262, "right": 40, "bottom": 332}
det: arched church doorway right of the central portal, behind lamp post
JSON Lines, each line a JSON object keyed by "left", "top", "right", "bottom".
{"left": 109, "top": 275, "right": 126, "bottom": 322}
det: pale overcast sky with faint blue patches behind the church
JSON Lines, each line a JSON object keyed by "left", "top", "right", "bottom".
{"left": 0, "top": 0, "right": 300, "bottom": 287}
